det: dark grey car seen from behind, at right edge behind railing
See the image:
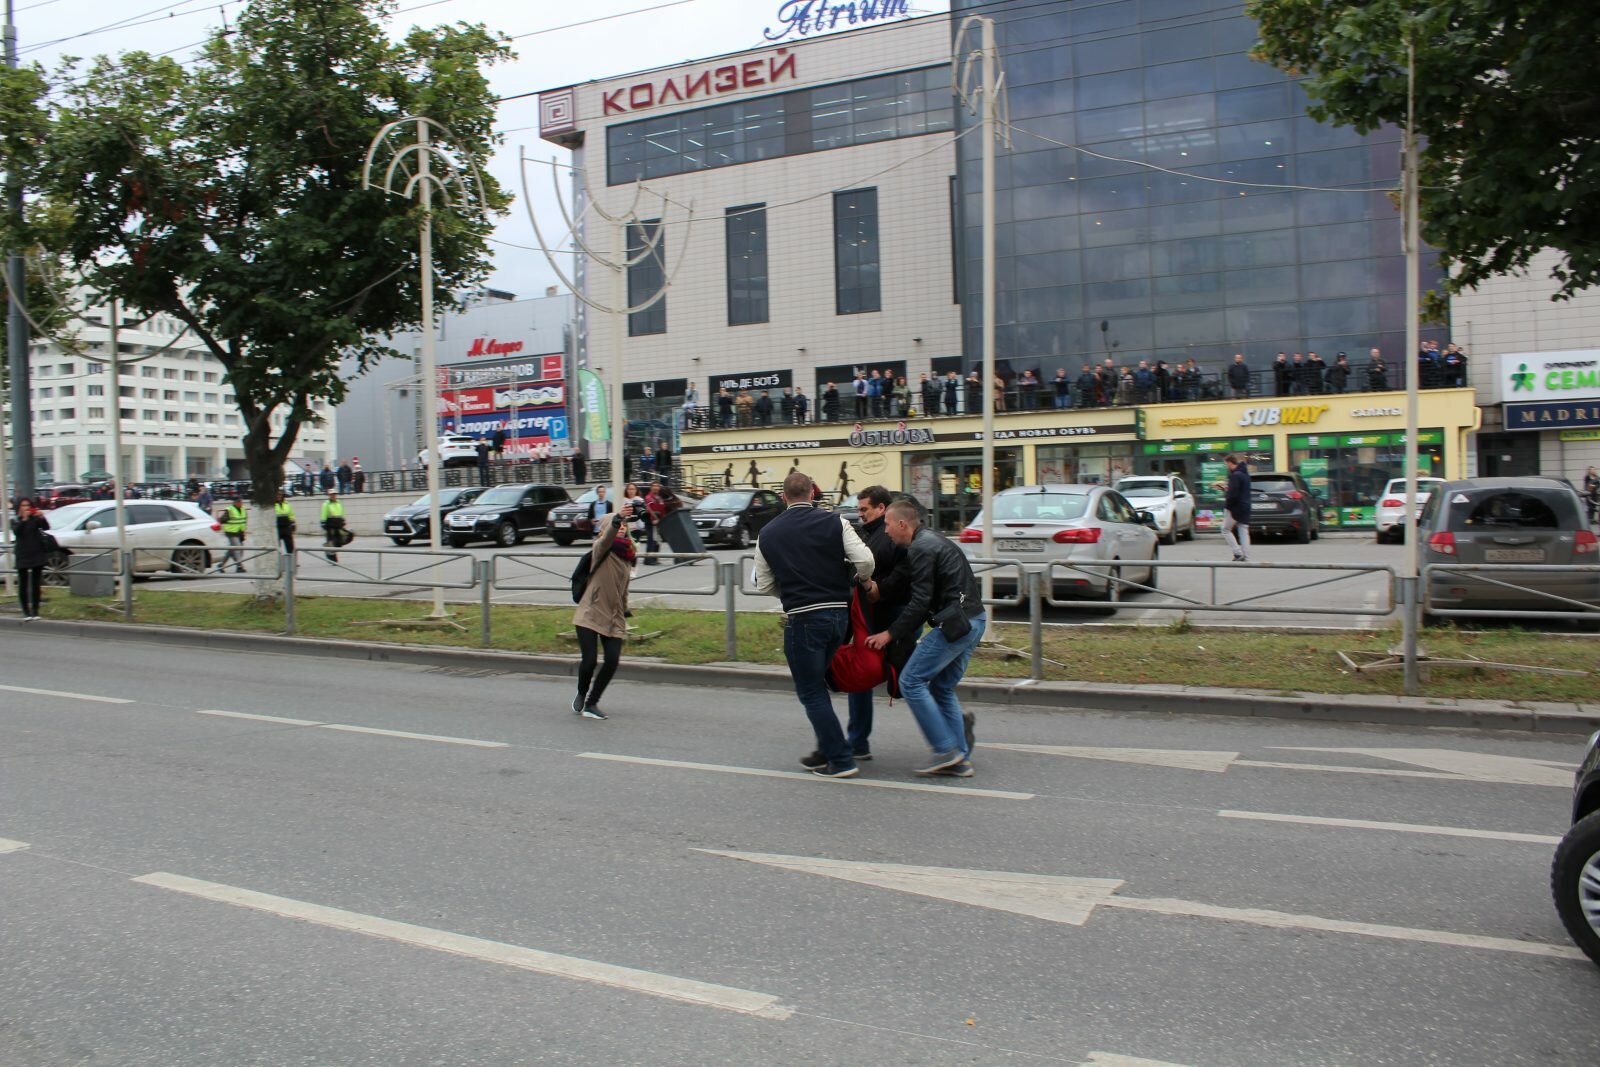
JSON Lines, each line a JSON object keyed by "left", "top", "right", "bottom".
{"left": 1416, "top": 478, "right": 1600, "bottom": 621}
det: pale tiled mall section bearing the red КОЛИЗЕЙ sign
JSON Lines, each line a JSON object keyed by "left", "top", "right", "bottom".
{"left": 539, "top": 14, "right": 962, "bottom": 454}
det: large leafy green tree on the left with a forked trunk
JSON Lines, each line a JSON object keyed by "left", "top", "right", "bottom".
{"left": 0, "top": 0, "right": 509, "bottom": 518}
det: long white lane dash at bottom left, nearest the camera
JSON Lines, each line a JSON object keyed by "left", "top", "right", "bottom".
{"left": 134, "top": 872, "right": 794, "bottom": 1019}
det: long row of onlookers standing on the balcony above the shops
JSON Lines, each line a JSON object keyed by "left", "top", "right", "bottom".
{"left": 683, "top": 341, "right": 1467, "bottom": 430}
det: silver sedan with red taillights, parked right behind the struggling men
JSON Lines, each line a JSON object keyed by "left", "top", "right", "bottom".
{"left": 960, "top": 485, "right": 1160, "bottom": 600}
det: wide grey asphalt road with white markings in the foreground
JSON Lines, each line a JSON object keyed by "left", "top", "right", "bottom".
{"left": 0, "top": 625, "right": 1600, "bottom": 1067}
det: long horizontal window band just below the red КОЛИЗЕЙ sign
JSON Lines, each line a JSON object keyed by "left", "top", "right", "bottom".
{"left": 606, "top": 66, "right": 952, "bottom": 186}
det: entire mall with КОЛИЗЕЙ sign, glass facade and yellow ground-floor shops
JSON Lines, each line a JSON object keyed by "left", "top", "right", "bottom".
{"left": 539, "top": 0, "right": 1510, "bottom": 530}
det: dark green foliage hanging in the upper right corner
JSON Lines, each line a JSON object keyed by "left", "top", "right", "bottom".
{"left": 1248, "top": 0, "right": 1600, "bottom": 299}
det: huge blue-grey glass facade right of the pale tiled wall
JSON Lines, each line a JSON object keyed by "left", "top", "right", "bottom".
{"left": 952, "top": 0, "right": 1443, "bottom": 379}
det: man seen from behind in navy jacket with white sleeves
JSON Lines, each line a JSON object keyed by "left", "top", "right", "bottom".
{"left": 755, "top": 470, "right": 872, "bottom": 777}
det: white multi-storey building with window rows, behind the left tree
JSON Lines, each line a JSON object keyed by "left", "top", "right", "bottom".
{"left": 8, "top": 303, "right": 333, "bottom": 485}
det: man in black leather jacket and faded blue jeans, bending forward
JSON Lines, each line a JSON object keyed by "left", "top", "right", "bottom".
{"left": 867, "top": 501, "right": 986, "bottom": 777}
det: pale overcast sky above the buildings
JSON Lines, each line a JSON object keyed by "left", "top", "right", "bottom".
{"left": 14, "top": 0, "right": 950, "bottom": 296}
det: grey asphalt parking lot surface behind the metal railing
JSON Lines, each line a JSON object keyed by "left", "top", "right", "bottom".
{"left": 147, "top": 534, "right": 1405, "bottom": 629}
